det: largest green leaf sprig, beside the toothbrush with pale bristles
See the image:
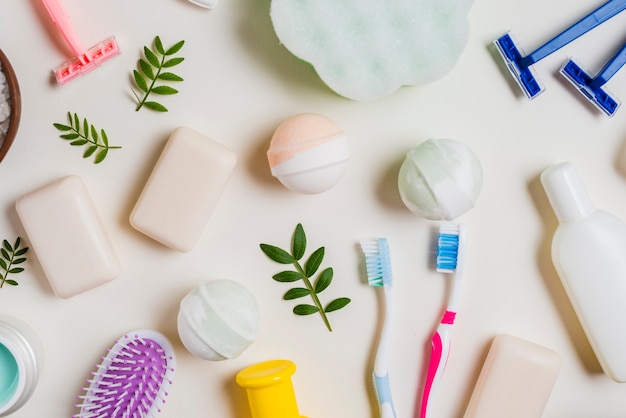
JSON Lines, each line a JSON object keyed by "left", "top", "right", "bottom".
{"left": 260, "top": 224, "right": 350, "bottom": 331}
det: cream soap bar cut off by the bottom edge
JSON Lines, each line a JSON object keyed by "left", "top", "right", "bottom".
{"left": 464, "top": 334, "right": 561, "bottom": 418}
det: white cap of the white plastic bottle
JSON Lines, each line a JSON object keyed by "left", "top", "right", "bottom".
{"left": 541, "top": 162, "right": 595, "bottom": 222}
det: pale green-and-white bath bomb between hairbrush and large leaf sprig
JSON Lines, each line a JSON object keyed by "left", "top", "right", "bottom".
{"left": 178, "top": 280, "right": 260, "bottom": 361}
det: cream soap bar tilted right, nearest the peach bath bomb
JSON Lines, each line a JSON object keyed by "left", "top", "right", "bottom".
{"left": 130, "top": 127, "right": 237, "bottom": 252}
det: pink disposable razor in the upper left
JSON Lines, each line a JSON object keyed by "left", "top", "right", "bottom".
{"left": 42, "top": 0, "right": 120, "bottom": 85}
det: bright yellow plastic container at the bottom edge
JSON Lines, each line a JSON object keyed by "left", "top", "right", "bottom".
{"left": 236, "top": 360, "right": 306, "bottom": 418}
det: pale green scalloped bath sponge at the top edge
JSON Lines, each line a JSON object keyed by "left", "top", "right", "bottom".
{"left": 270, "top": 0, "right": 473, "bottom": 100}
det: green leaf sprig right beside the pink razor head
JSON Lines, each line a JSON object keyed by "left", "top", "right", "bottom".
{"left": 132, "top": 36, "right": 185, "bottom": 112}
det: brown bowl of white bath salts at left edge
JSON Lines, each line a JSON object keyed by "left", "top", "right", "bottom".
{"left": 0, "top": 49, "right": 22, "bottom": 162}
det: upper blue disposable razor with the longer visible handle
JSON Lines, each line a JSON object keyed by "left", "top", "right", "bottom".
{"left": 494, "top": 0, "right": 626, "bottom": 99}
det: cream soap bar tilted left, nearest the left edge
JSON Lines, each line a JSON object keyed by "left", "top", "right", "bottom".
{"left": 15, "top": 175, "right": 121, "bottom": 298}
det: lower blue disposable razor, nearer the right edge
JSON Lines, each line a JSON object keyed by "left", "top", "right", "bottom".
{"left": 561, "top": 44, "right": 626, "bottom": 116}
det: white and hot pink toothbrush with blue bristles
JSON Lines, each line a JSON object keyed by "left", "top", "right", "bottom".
{"left": 420, "top": 224, "right": 465, "bottom": 418}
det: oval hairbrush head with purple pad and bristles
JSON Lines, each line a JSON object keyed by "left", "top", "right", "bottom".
{"left": 73, "top": 330, "right": 175, "bottom": 418}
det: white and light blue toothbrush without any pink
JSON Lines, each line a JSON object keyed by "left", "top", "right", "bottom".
{"left": 361, "top": 238, "right": 396, "bottom": 418}
